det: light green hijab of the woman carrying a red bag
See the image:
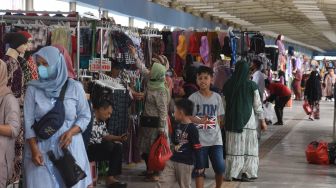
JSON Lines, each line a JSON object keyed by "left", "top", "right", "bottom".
{"left": 148, "top": 63, "right": 167, "bottom": 91}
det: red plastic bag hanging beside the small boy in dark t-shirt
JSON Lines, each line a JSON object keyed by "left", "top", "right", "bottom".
{"left": 148, "top": 134, "right": 173, "bottom": 171}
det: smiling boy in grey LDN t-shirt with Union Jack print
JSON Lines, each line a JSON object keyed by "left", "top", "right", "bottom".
{"left": 189, "top": 66, "right": 225, "bottom": 188}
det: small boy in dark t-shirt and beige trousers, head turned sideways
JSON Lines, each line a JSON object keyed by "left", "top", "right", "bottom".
{"left": 157, "top": 99, "right": 201, "bottom": 188}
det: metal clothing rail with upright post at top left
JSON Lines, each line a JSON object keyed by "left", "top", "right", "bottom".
{"left": 0, "top": 10, "right": 81, "bottom": 78}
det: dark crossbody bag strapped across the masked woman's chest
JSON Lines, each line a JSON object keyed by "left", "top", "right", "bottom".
{"left": 32, "top": 81, "right": 68, "bottom": 140}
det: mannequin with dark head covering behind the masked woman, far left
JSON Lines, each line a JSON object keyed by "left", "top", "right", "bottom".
{"left": 3, "top": 33, "right": 28, "bottom": 184}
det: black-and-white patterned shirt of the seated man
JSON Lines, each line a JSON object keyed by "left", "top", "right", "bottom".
{"left": 89, "top": 118, "right": 109, "bottom": 145}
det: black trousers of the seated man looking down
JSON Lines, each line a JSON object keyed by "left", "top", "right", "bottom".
{"left": 87, "top": 142, "right": 123, "bottom": 176}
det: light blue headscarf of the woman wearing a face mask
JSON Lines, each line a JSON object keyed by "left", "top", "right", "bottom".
{"left": 28, "top": 46, "right": 68, "bottom": 98}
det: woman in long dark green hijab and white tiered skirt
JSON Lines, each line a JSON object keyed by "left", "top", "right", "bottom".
{"left": 224, "top": 61, "right": 267, "bottom": 181}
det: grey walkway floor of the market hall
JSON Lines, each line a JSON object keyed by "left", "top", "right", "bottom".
{"left": 98, "top": 102, "right": 336, "bottom": 188}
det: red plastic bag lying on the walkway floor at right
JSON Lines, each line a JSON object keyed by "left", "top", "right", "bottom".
{"left": 306, "top": 141, "right": 329, "bottom": 165}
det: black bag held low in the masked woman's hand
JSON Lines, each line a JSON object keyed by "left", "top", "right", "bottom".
{"left": 47, "top": 149, "right": 86, "bottom": 187}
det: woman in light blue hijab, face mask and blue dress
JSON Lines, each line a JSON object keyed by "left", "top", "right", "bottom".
{"left": 24, "top": 46, "right": 92, "bottom": 188}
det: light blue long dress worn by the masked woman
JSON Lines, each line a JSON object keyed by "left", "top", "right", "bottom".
{"left": 24, "top": 79, "right": 92, "bottom": 188}
